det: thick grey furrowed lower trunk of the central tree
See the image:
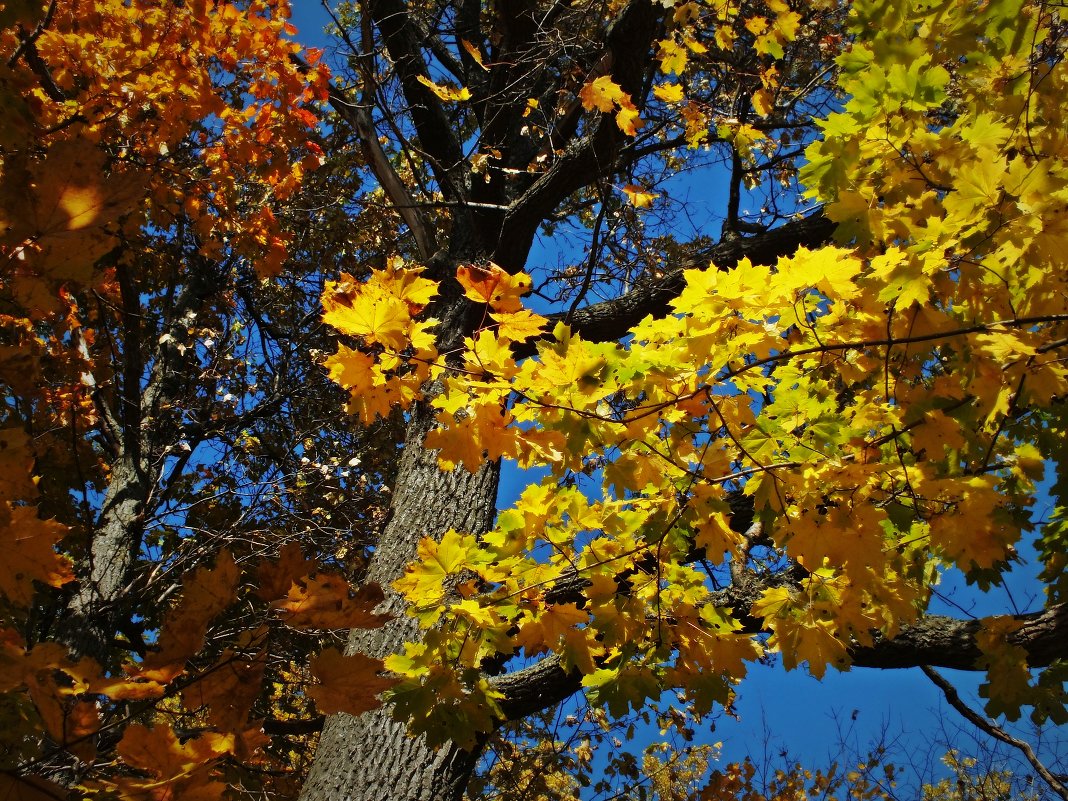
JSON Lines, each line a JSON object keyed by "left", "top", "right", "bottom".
{"left": 300, "top": 408, "right": 500, "bottom": 801}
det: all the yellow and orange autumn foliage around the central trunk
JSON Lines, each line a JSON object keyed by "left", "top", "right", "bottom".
{"left": 0, "top": 0, "right": 1068, "bottom": 800}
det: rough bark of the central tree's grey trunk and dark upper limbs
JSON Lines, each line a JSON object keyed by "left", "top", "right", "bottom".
{"left": 301, "top": 0, "right": 850, "bottom": 801}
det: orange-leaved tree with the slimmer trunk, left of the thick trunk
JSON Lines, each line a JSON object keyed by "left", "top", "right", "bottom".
{"left": 0, "top": 2, "right": 395, "bottom": 797}
